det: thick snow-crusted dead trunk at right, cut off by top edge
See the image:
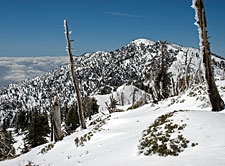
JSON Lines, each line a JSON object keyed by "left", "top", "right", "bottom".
{"left": 193, "top": 0, "right": 224, "bottom": 111}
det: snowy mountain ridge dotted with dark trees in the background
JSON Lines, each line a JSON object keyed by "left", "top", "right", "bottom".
{"left": 0, "top": 39, "right": 225, "bottom": 123}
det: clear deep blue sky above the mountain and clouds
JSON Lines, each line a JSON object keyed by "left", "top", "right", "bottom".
{"left": 0, "top": 0, "right": 225, "bottom": 57}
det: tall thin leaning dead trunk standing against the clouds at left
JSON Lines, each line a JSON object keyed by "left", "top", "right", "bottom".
{"left": 64, "top": 20, "right": 87, "bottom": 129}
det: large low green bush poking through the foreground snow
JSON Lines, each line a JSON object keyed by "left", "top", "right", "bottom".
{"left": 138, "top": 110, "right": 197, "bottom": 156}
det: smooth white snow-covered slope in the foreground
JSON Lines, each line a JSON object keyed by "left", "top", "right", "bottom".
{"left": 0, "top": 80, "right": 225, "bottom": 166}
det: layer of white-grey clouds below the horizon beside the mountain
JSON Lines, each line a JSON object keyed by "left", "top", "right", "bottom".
{"left": 0, "top": 56, "right": 68, "bottom": 88}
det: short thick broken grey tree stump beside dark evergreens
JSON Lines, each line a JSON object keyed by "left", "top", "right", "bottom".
{"left": 52, "top": 96, "right": 63, "bottom": 141}
